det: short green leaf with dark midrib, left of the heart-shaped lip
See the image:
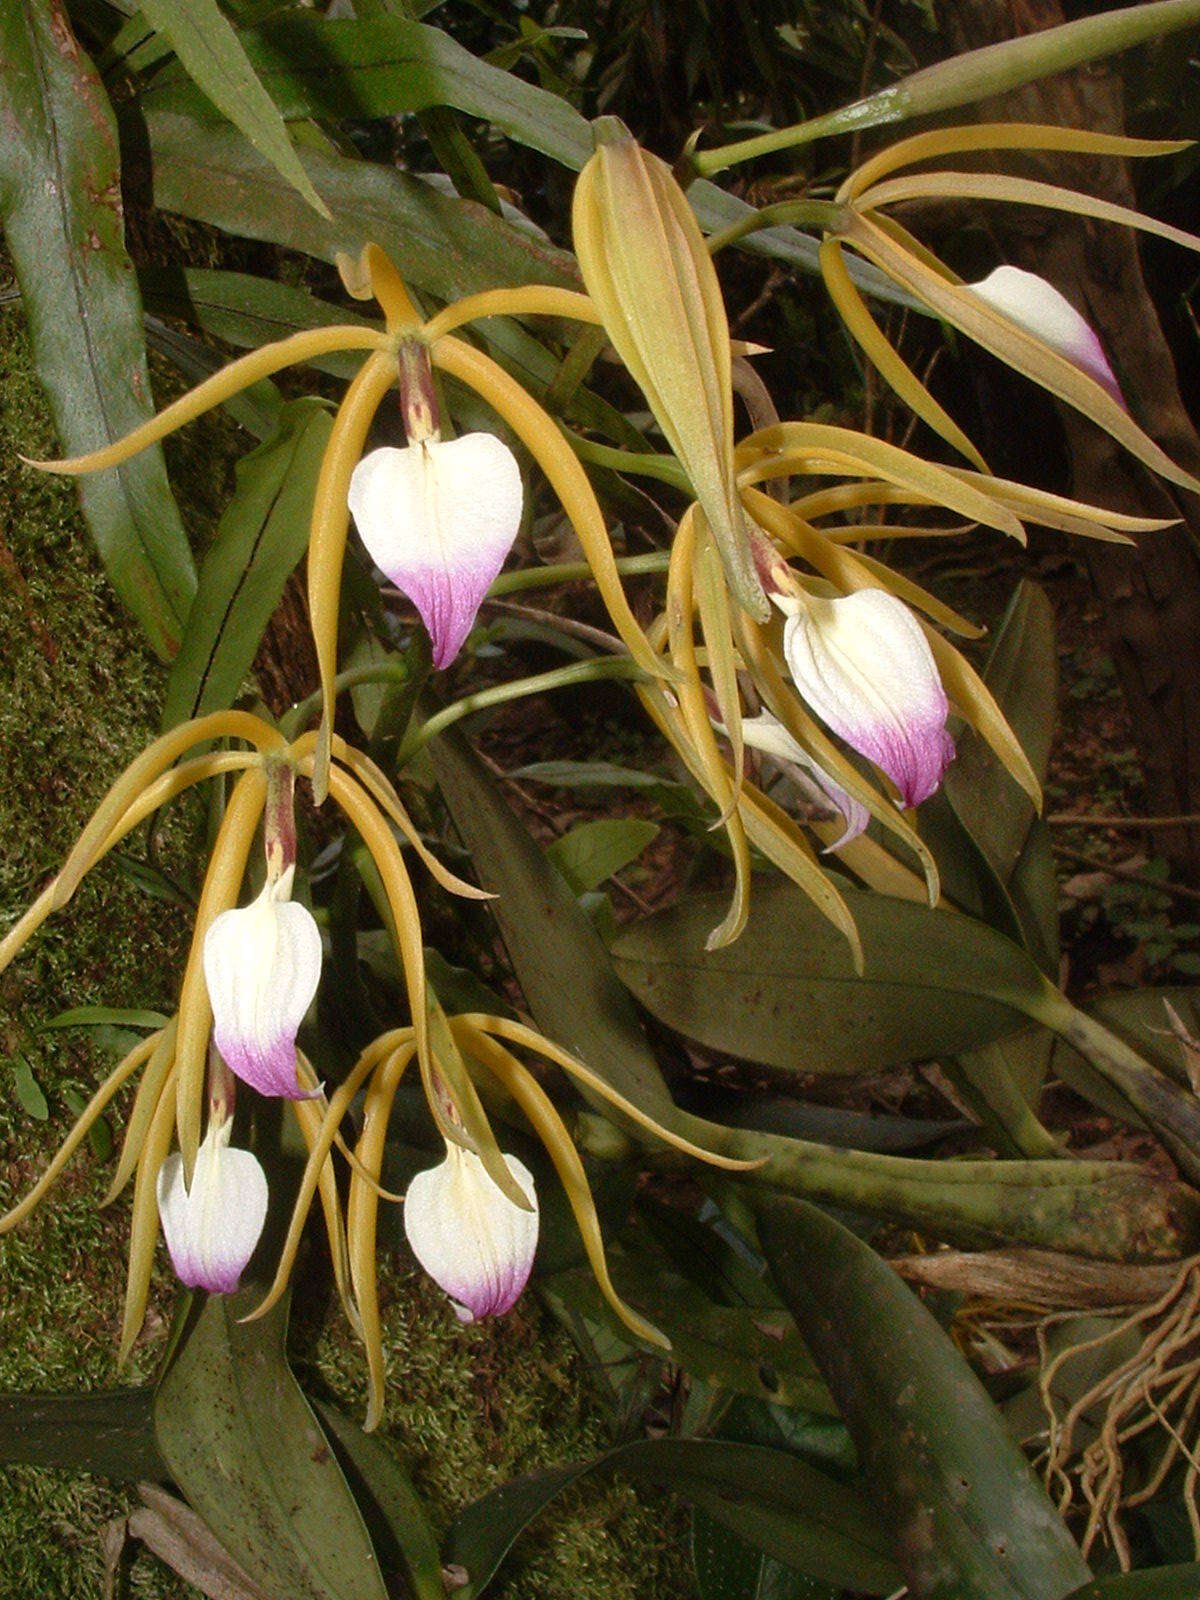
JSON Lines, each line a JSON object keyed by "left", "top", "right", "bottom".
{"left": 163, "top": 400, "right": 333, "bottom": 728}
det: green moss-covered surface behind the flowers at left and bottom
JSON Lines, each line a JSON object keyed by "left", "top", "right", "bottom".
{"left": 0, "top": 307, "right": 690, "bottom": 1600}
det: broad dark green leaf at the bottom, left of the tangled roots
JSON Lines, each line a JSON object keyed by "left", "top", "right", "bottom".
{"left": 758, "top": 1198, "right": 1088, "bottom": 1600}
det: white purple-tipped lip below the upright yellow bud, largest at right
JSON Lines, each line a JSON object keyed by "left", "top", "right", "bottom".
{"left": 784, "top": 589, "right": 954, "bottom": 806}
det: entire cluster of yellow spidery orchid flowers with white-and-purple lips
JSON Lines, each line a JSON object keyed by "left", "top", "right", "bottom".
{"left": 0, "top": 123, "right": 1200, "bottom": 1422}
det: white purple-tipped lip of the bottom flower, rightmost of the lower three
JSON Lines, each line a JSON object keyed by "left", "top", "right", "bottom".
{"left": 405, "top": 1144, "right": 538, "bottom": 1322}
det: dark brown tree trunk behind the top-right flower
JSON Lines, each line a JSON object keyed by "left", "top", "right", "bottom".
{"left": 942, "top": 0, "right": 1200, "bottom": 882}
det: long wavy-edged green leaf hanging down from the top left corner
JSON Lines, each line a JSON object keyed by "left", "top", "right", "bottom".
{"left": 0, "top": 0, "right": 195, "bottom": 661}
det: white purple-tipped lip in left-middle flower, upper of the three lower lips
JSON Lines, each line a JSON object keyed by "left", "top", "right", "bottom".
{"left": 203, "top": 872, "right": 322, "bottom": 1099}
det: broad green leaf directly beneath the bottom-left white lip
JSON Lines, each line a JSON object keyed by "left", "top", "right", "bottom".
{"left": 154, "top": 1285, "right": 387, "bottom": 1600}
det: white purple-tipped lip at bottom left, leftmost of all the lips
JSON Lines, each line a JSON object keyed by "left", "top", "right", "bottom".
{"left": 158, "top": 1122, "right": 267, "bottom": 1294}
